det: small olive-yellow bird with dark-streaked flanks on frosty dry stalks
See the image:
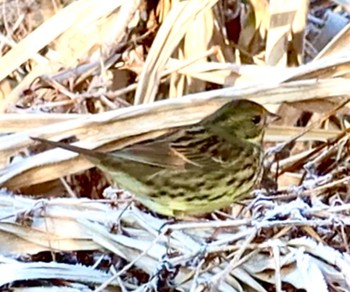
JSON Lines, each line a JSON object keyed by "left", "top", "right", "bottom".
{"left": 32, "top": 99, "right": 277, "bottom": 218}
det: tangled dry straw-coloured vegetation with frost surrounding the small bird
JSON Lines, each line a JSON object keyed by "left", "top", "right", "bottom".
{"left": 0, "top": 0, "right": 350, "bottom": 292}
